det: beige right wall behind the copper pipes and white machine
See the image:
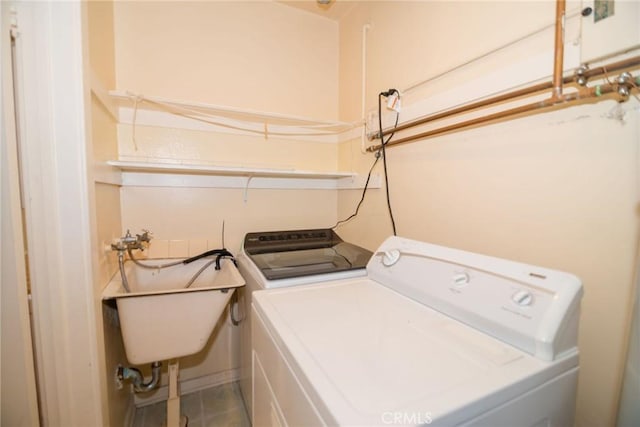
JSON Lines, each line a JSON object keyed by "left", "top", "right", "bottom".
{"left": 338, "top": 1, "right": 640, "bottom": 426}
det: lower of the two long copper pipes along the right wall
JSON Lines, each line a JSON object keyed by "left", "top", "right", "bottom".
{"left": 367, "top": 83, "right": 617, "bottom": 151}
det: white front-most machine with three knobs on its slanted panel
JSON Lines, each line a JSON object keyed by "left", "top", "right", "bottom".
{"left": 252, "top": 237, "right": 582, "bottom": 427}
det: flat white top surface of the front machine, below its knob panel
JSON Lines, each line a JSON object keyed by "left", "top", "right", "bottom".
{"left": 253, "top": 278, "right": 577, "bottom": 425}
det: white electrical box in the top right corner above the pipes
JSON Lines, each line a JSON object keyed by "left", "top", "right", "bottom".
{"left": 581, "top": 0, "right": 640, "bottom": 63}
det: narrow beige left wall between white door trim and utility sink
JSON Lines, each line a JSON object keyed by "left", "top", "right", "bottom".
{"left": 85, "top": 1, "right": 134, "bottom": 426}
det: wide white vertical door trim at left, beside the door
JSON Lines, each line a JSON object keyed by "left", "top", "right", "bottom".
{"left": 10, "top": 1, "right": 107, "bottom": 426}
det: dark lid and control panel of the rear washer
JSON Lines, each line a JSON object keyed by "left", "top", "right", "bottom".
{"left": 244, "top": 229, "right": 372, "bottom": 280}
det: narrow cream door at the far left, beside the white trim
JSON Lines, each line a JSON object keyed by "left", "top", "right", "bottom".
{"left": 0, "top": 3, "right": 40, "bottom": 426}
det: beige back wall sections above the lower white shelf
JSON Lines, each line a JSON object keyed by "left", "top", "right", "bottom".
{"left": 115, "top": 1, "right": 338, "bottom": 172}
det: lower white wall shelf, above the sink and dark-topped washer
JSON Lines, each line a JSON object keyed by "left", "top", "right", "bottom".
{"left": 103, "top": 160, "right": 381, "bottom": 189}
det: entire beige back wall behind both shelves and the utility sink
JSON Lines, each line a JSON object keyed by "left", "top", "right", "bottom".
{"left": 113, "top": 1, "right": 338, "bottom": 399}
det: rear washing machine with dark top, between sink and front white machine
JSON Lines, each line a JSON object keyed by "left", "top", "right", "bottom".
{"left": 237, "top": 229, "right": 372, "bottom": 414}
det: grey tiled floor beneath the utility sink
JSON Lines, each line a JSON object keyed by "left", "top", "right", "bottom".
{"left": 133, "top": 383, "right": 251, "bottom": 427}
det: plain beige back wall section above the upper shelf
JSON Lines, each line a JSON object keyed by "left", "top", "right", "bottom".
{"left": 115, "top": 1, "right": 338, "bottom": 119}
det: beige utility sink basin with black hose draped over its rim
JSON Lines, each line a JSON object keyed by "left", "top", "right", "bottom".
{"left": 102, "top": 258, "right": 245, "bottom": 365}
